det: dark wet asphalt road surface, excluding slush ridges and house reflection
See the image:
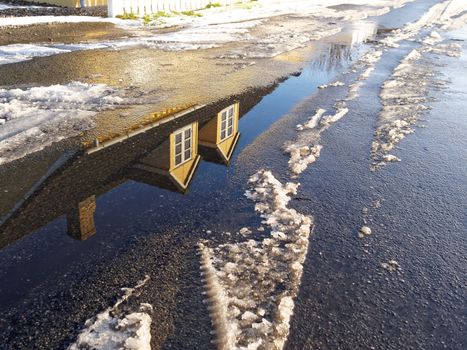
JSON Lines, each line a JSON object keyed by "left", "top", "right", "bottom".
{"left": 0, "top": 1, "right": 467, "bottom": 349}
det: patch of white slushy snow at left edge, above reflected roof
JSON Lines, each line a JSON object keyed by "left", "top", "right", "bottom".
{"left": 0, "top": 82, "right": 127, "bottom": 164}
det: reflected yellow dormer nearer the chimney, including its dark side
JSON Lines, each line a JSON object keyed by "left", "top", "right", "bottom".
{"left": 128, "top": 122, "right": 200, "bottom": 192}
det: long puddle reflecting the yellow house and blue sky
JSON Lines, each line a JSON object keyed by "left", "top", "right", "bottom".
{"left": 0, "top": 35, "right": 368, "bottom": 306}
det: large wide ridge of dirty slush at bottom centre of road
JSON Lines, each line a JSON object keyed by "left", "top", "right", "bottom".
{"left": 199, "top": 170, "right": 312, "bottom": 350}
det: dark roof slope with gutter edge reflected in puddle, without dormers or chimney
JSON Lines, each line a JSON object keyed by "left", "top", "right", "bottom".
{"left": 0, "top": 84, "right": 277, "bottom": 249}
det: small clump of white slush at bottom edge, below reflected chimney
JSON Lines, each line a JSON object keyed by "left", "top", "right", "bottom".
{"left": 68, "top": 276, "right": 152, "bottom": 350}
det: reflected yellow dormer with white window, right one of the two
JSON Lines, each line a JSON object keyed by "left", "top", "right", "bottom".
{"left": 199, "top": 103, "right": 240, "bottom": 164}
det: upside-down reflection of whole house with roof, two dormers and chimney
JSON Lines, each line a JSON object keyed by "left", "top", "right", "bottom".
{"left": 0, "top": 85, "right": 276, "bottom": 248}
